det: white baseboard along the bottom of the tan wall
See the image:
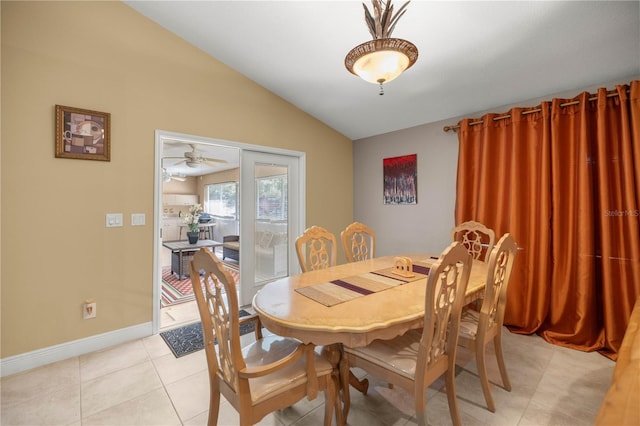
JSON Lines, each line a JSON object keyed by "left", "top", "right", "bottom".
{"left": 0, "top": 322, "right": 153, "bottom": 377}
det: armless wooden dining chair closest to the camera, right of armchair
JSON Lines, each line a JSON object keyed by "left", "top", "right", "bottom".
{"left": 340, "top": 242, "right": 472, "bottom": 425}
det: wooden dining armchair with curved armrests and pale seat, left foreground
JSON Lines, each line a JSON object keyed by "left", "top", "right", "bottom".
{"left": 190, "top": 249, "right": 338, "bottom": 426}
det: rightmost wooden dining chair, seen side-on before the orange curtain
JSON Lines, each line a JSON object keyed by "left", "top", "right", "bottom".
{"left": 458, "top": 233, "right": 517, "bottom": 412}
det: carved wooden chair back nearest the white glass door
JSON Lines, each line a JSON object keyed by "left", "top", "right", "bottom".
{"left": 296, "top": 225, "right": 337, "bottom": 272}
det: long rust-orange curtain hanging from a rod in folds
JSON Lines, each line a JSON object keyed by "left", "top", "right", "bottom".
{"left": 456, "top": 81, "right": 640, "bottom": 358}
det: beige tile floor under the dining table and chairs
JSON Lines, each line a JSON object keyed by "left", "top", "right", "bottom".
{"left": 0, "top": 306, "right": 615, "bottom": 426}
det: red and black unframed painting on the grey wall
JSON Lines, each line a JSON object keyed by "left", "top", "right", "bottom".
{"left": 382, "top": 154, "right": 418, "bottom": 204}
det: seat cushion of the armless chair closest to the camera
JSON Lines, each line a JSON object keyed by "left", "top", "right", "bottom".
{"left": 344, "top": 330, "right": 422, "bottom": 380}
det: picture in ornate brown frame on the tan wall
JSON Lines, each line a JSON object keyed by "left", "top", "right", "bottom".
{"left": 56, "top": 105, "right": 111, "bottom": 161}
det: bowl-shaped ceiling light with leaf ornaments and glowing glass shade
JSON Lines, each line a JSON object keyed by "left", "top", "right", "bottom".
{"left": 344, "top": 0, "right": 418, "bottom": 95}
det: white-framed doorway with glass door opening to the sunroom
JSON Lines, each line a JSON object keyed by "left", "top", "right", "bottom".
{"left": 153, "top": 130, "right": 305, "bottom": 333}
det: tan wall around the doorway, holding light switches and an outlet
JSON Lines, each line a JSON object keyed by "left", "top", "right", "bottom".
{"left": 0, "top": 1, "right": 353, "bottom": 358}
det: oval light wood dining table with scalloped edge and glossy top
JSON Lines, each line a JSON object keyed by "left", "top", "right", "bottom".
{"left": 252, "top": 254, "right": 487, "bottom": 424}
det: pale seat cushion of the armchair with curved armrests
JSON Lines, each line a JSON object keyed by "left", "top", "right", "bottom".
{"left": 242, "top": 335, "right": 333, "bottom": 404}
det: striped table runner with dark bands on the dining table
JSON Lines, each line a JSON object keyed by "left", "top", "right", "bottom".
{"left": 296, "top": 263, "right": 429, "bottom": 306}
